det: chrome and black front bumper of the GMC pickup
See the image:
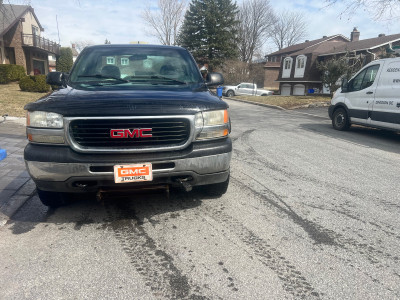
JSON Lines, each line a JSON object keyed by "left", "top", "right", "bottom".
{"left": 24, "top": 138, "right": 232, "bottom": 192}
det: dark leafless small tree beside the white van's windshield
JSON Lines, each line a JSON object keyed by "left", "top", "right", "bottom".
{"left": 317, "top": 53, "right": 364, "bottom": 95}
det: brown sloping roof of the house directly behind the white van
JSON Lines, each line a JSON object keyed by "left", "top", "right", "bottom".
{"left": 319, "top": 34, "right": 400, "bottom": 56}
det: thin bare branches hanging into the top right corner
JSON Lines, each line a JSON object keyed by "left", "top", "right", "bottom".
{"left": 326, "top": 0, "right": 400, "bottom": 21}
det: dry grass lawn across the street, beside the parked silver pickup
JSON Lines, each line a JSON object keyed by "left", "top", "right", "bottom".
{"left": 233, "top": 95, "right": 331, "bottom": 109}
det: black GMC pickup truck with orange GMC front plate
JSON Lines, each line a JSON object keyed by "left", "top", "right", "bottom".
{"left": 24, "top": 45, "right": 232, "bottom": 207}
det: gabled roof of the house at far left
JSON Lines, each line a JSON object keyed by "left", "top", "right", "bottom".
{"left": 0, "top": 4, "right": 44, "bottom": 35}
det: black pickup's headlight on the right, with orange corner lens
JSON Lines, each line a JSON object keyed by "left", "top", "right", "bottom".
{"left": 195, "top": 109, "right": 230, "bottom": 140}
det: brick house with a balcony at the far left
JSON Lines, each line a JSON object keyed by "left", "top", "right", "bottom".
{"left": 0, "top": 4, "right": 60, "bottom": 75}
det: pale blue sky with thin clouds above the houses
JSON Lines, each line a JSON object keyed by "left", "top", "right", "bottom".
{"left": 7, "top": 0, "right": 400, "bottom": 52}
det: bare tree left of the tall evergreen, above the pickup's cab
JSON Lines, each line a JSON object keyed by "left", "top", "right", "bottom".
{"left": 142, "top": 0, "right": 186, "bottom": 45}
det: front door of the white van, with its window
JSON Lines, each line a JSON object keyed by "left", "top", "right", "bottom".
{"left": 346, "top": 64, "right": 379, "bottom": 124}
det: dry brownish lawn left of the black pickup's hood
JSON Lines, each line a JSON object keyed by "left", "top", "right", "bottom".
{"left": 0, "top": 82, "right": 46, "bottom": 117}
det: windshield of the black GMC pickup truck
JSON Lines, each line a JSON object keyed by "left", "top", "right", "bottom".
{"left": 69, "top": 46, "right": 202, "bottom": 88}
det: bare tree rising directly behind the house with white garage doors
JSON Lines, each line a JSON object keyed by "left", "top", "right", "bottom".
{"left": 271, "top": 12, "right": 307, "bottom": 50}
